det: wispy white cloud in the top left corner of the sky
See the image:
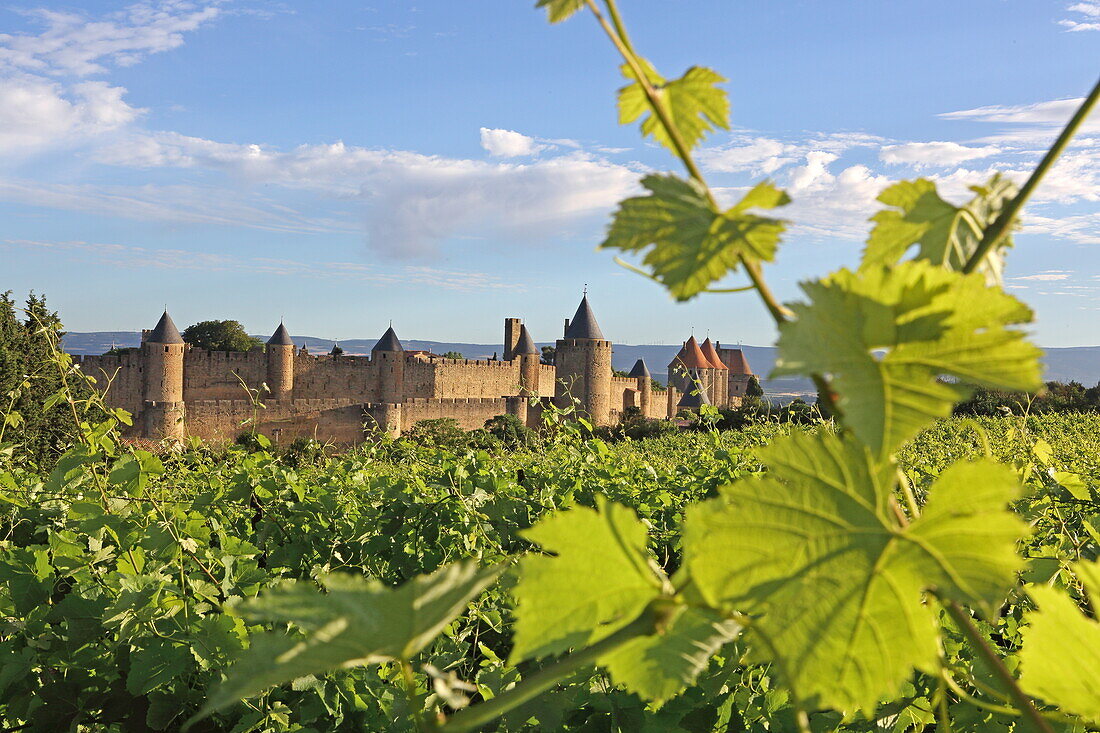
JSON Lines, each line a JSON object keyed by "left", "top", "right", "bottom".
{"left": 0, "top": 0, "right": 219, "bottom": 76}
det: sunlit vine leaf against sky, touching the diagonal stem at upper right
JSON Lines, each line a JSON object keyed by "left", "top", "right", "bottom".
{"left": 864, "top": 174, "right": 1019, "bottom": 284}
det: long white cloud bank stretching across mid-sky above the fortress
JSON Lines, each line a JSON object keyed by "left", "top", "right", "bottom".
{"left": 25, "top": 133, "right": 638, "bottom": 258}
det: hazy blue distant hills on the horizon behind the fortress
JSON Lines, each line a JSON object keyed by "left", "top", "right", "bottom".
{"left": 64, "top": 331, "right": 1100, "bottom": 402}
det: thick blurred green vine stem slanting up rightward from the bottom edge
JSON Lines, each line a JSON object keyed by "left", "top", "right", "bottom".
{"left": 439, "top": 608, "right": 659, "bottom": 733}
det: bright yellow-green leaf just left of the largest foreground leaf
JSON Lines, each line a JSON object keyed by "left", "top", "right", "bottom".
{"left": 509, "top": 496, "right": 669, "bottom": 665}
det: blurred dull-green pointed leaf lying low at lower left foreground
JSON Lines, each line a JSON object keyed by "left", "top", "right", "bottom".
{"left": 196, "top": 562, "right": 503, "bottom": 719}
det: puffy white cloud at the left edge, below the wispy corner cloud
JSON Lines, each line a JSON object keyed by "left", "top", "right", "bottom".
{"left": 0, "top": 75, "right": 143, "bottom": 155}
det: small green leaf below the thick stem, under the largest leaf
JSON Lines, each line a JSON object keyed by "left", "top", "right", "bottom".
{"left": 597, "top": 605, "right": 741, "bottom": 705}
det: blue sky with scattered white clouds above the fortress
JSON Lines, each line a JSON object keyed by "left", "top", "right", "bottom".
{"left": 0, "top": 0, "right": 1100, "bottom": 346}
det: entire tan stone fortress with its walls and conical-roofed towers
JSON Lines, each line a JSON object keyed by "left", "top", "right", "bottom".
{"left": 75, "top": 296, "right": 751, "bottom": 445}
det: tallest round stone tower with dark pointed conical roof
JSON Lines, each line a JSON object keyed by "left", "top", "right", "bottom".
{"left": 554, "top": 295, "right": 612, "bottom": 425}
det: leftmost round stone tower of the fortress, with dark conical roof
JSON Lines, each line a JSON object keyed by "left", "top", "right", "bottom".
{"left": 141, "top": 310, "right": 187, "bottom": 440}
